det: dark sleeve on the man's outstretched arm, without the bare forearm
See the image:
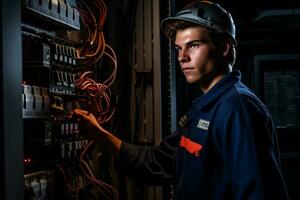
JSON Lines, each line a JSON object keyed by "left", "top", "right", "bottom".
{"left": 118, "top": 131, "right": 179, "bottom": 185}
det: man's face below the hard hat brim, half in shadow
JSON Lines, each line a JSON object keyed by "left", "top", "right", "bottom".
{"left": 175, "top": 27, "right": 215, "bottom": 83}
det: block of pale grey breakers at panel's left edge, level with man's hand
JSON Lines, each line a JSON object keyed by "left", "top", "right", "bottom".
{"left": 22, "top": 84, "right": 50, "bottom": 118}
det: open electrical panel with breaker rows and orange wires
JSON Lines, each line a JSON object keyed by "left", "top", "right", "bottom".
{"left": 21, "top": 0, "right": 118, "bottom": 200}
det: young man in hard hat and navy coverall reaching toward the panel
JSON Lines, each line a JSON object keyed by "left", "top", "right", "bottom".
{"left": 73, "top": 1, "right": 288, "bottom": 200}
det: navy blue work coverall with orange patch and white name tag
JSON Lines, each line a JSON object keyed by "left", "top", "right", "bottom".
{"left": 119, "top": 71, "right": 288, "bottom": 200}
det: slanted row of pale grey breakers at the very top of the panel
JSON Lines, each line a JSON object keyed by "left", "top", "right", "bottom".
{"left": 25, "top": 0, "right": 80, "bottom": 29}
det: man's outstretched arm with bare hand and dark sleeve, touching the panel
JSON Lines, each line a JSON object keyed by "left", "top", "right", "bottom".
{"left": 70, "top": 109, "right": 179, "bottom": 185}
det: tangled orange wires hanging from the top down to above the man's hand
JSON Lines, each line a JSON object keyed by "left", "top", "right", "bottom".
{"left": 76, "top": 0, "right": 117, "bottom": 123}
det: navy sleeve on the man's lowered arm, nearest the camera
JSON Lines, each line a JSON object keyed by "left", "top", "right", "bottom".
{"left": 214, "top": 102, "right": 288, "bottom": 200}
